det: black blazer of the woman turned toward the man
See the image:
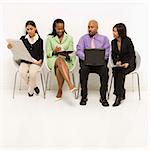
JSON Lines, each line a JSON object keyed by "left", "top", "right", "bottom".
{"left": 111, "top": 37, "right": 136, "bottom": 68}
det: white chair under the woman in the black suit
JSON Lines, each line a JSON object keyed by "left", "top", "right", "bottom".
{"left": 108, "top": 51, "right": 141, "bottom": 100}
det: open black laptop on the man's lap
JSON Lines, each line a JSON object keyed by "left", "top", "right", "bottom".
{"left": 84, "top": 48, "right": 105, "bottom": 66}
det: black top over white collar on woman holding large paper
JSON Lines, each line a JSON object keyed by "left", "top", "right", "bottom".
{"left": 20, "top": 36, "right": 44, "bottom": 61}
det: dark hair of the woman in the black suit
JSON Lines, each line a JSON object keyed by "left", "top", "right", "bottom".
{"left": 113, "top": 23, "right": 127, "bottom": 38}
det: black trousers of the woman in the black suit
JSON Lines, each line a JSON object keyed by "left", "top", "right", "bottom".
{"left": 113, "top": 67, "right": 135, "bottom": 97}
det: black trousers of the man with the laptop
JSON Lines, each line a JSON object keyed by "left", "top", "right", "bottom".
{"left": 79, "top": 60, "right": 108, "bottom": 99}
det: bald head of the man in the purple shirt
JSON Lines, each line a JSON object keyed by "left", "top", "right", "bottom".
{"left": 88, "top": 20, "right": 98, "bottom": 36}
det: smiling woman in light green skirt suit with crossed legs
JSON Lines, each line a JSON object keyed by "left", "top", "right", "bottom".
{"left": 46, "top": 19, "right": 76, "bottom": 100}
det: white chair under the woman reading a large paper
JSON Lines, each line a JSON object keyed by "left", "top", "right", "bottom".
{"left": 13, "top": 60, "right": 44, "bottom": 99}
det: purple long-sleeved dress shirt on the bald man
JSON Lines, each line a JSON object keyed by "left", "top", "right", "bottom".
{"left": 76, "top": 33, "right": 110, "bottom": 60}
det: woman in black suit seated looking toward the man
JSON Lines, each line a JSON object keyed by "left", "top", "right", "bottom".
{"left": 111, "top": 23, "right": 136, "bottom": 106}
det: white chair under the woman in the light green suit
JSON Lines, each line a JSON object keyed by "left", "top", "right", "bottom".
{"left": 44, "top": 54, "right": 77, "bottom": 98}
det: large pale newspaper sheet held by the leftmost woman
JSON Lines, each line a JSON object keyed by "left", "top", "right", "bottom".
{"left": 6, "top": 39, "right": 33, "bottom": 62}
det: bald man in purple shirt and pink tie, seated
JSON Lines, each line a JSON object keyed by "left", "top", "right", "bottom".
{"left": 76, "top": 20, "right": 110, "bottom": 106}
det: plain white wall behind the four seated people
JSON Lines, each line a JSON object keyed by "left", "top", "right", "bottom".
{"left": 1, "top": 3, "right": 149, "bottom": 89}
